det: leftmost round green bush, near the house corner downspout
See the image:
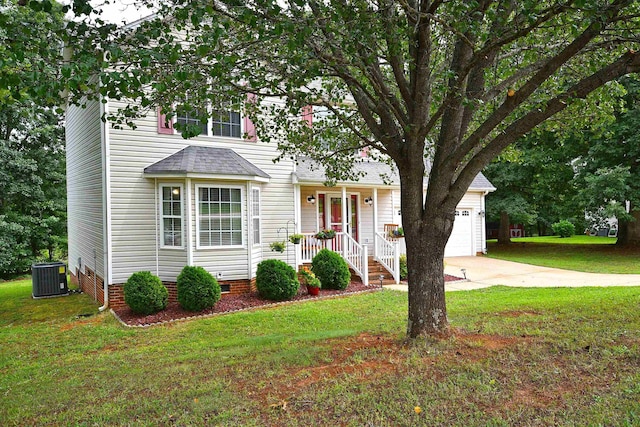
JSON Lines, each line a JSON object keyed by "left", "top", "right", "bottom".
{"left": 124, "top": 271, "right": 169, "bottom": 314}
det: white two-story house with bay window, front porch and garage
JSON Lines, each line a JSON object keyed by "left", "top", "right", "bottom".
{"left": 66, "top": 97, "right": 494, "bottom": 307}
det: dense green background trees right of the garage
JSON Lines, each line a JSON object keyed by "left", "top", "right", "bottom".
{"left": 484, "top": 75, "right": 640, "bottom": 245}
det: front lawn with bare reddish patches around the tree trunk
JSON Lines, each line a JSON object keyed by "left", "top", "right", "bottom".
{"left": 0, "top": 281, "right": 640, "bottom": 426}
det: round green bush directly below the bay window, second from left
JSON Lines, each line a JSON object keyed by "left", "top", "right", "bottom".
{"left": 176, "top": 265, "right": 220, "bottom": 311}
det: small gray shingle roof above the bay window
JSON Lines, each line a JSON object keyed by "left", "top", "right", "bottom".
{"left": 144, "top": 145, "right": 270, "bottom": 179}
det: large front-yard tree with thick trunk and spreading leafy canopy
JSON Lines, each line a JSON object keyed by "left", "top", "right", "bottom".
{"left": 57, "top": 0, "right": 640, "bottom": 337}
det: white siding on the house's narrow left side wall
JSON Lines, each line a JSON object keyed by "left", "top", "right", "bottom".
{"left": 66, "top": 101, "right": 105, "bottom": 278}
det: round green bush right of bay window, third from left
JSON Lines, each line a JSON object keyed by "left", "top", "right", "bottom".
{"left": 256, "top": 259, "right": 300, "bottom": 301}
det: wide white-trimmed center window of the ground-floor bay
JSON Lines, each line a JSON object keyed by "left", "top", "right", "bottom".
{"left": 197, "top": 187, "right": 242, "bottom": 247}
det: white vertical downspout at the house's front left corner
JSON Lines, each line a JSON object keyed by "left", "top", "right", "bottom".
{"left": 94, "top": 93, "right": 113, "bottom": 311}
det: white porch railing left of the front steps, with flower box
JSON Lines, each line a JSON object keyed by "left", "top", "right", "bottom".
{"left": 298, "top": 232, "right": 369, "bottom": 286}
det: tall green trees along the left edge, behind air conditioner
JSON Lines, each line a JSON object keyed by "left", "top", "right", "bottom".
{"left": 0, "top": 1, "right": 66, "bottom": 277}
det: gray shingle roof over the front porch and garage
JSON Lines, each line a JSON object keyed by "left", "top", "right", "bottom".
{"left": 296, "top": 157, "right": 495, "bottom": 191}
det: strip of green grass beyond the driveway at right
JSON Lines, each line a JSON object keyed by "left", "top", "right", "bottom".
{"left": 487, "top": 236, "right": 640, "bottom": 274}
